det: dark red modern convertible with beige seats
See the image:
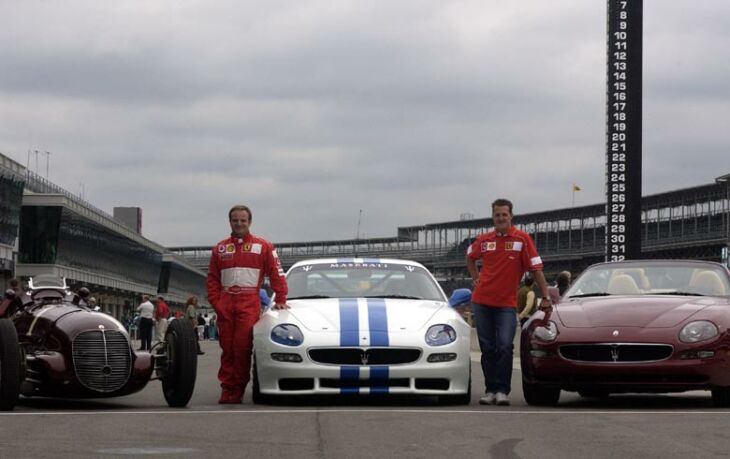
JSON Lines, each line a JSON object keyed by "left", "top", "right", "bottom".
{"left": 520, "top": 260, "right": 730, "bottom": 407}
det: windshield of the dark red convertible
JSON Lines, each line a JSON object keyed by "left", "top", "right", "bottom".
{"left": 564, "top": 261, "right": 730, "bottom": 299}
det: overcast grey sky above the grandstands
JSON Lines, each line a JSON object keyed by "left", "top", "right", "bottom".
{"left": 0, "top": 0, "right": 730, "bottom": 246}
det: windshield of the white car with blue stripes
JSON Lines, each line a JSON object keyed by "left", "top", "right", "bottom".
{"left": 286, "top": 262, "right": 446, "bottom": 301}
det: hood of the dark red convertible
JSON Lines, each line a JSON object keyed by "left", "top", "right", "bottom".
{"left": 555, "top": 295, "right": 718, "bottom": 328}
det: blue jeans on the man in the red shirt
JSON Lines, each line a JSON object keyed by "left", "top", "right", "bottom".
{"left": 472, "top": 303, "right": 517, "bottom": 394}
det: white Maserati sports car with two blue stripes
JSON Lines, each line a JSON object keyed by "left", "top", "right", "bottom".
{"left": 253, "top": 258, "right": 471, "bottom": 404}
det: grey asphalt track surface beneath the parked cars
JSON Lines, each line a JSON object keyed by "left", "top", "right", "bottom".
{"left": 0, "top": 336, "right": 730, "bottom": 458}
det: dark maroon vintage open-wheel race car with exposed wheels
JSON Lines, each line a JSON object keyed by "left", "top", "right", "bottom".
{"left": 0, "top": 276, "right": 198, "bottom": 410}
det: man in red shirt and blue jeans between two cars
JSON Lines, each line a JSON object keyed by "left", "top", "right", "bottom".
{"left": 466, "top": 199, "right": 551, "bottom": 405}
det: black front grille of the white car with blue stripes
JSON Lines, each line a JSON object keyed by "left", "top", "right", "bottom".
{"left": 309, "top": 347, "right": 421, "bottom": 366}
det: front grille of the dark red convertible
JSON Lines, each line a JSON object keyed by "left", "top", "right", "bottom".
{"left": 560, "top": 343, "right": 674, "bottom": 363}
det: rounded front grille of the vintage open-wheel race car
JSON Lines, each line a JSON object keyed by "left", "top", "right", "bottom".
{"left": 73, "top": 330, "right": 132, "bottom": 392}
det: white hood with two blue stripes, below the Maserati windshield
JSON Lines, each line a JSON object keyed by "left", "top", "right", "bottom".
{"left": 282, "top": 298, "right": 448, "bottom": 332}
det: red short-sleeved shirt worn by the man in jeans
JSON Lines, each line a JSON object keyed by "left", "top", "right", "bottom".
{"left": 466, "top": 226, "right": 542, "bottom": 308}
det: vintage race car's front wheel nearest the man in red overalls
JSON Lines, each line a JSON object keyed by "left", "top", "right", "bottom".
{"left": 162, "top": 320, "right": 198, "bottom": 408}
